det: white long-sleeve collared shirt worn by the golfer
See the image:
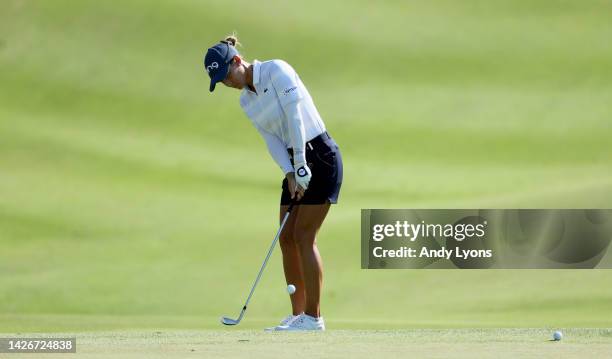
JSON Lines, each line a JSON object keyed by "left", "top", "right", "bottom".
{"left": 240, "top": 60, "right": 325, "bottom": 174}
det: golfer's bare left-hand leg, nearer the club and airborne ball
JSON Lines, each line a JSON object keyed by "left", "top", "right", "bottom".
{"left": 279, "top": 206, "right": 306, "bottom": 315}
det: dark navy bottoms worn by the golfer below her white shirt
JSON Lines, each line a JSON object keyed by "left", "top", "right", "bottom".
{"left": 281, "top": 132, "right": 342, "bottom": 205}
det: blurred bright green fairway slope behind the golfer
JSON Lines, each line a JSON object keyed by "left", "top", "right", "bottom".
{"left": 0, "top": 0, "right": 612, "bottom": 332}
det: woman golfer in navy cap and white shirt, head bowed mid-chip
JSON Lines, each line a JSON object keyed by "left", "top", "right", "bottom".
{"left": 204, "top": 35, "right": 342, "bottom": 330}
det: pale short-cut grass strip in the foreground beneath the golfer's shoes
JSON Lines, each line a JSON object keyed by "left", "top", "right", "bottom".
{"left": 1, "top": 329, "right": 612, "bottom": 359}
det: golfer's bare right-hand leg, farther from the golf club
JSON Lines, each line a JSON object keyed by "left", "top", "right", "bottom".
{"left": 294, "top": 204, "right": 330, "bottom": 318}
